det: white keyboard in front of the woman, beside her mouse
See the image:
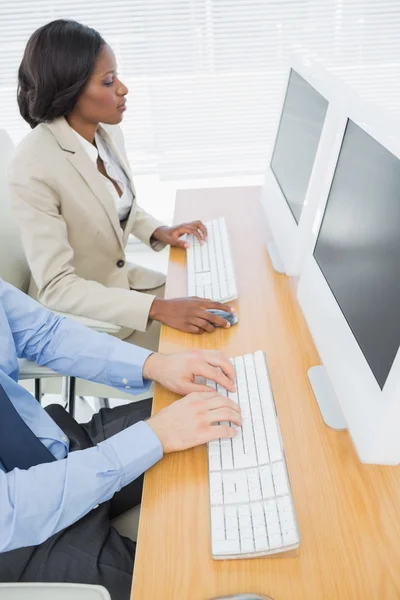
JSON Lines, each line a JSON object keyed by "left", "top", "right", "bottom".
{"left": 186, "top": 217, "right": 238, "bottom": 302}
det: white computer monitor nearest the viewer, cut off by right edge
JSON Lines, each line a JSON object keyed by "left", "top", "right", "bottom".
{"left": 298, "top": 104, "right": 400, "bottom": 464}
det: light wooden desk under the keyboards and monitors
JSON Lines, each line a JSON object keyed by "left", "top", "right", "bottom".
{"left": 132, "top": 188, "right": 400, "bottom": 600}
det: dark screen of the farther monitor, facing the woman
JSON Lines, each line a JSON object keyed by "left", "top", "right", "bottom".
{"left": 271, "top": 69, "right": 328, "bottom": 223}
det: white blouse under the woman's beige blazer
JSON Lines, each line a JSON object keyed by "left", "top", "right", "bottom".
{"left": 71, "top": 128, "right": 133, "bottom": 221}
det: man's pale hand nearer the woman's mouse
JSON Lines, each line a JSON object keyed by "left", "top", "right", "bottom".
{"left": 143, "top": 350, "right": 236, "bottom": 395}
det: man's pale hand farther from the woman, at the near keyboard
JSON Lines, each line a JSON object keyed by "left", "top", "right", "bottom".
{"left": 147, "top": 392, "right": 242, "bottom": 454}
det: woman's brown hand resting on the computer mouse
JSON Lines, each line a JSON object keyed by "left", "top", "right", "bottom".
{"left": 149, "top": 297, "right": 235, "bottom": 334}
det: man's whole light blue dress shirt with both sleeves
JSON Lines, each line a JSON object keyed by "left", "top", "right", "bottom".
{"left": 0, "top": 279, "right": 162, "bottom": 560}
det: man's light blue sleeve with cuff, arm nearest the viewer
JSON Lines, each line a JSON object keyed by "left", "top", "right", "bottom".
{"left": 0, "top": 421, "right": 162, "bottom": 552}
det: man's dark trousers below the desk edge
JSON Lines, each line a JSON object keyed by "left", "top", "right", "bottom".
{"left": 0, "top": 400, "right": 151, "bottom": 600}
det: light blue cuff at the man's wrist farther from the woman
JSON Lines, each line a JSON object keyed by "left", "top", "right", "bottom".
{"left": 99, "top": 421, "right": 163, "bottom": 487}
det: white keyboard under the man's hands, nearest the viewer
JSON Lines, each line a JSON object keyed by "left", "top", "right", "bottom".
{"left": 207, "top": 351, "right": 300, "bottom": 559}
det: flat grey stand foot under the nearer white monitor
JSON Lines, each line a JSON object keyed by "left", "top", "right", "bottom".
{"left": 308, "top": 365, "right": 347, "bottom": 431}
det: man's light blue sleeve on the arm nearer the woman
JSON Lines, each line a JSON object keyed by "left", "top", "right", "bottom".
{"left": 0, "top": 280, "right": 152, "bottom": 394}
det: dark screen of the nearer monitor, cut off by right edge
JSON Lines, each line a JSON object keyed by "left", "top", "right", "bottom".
{"left": 314, "top": 120, "right": 400, "bottom": 388}
